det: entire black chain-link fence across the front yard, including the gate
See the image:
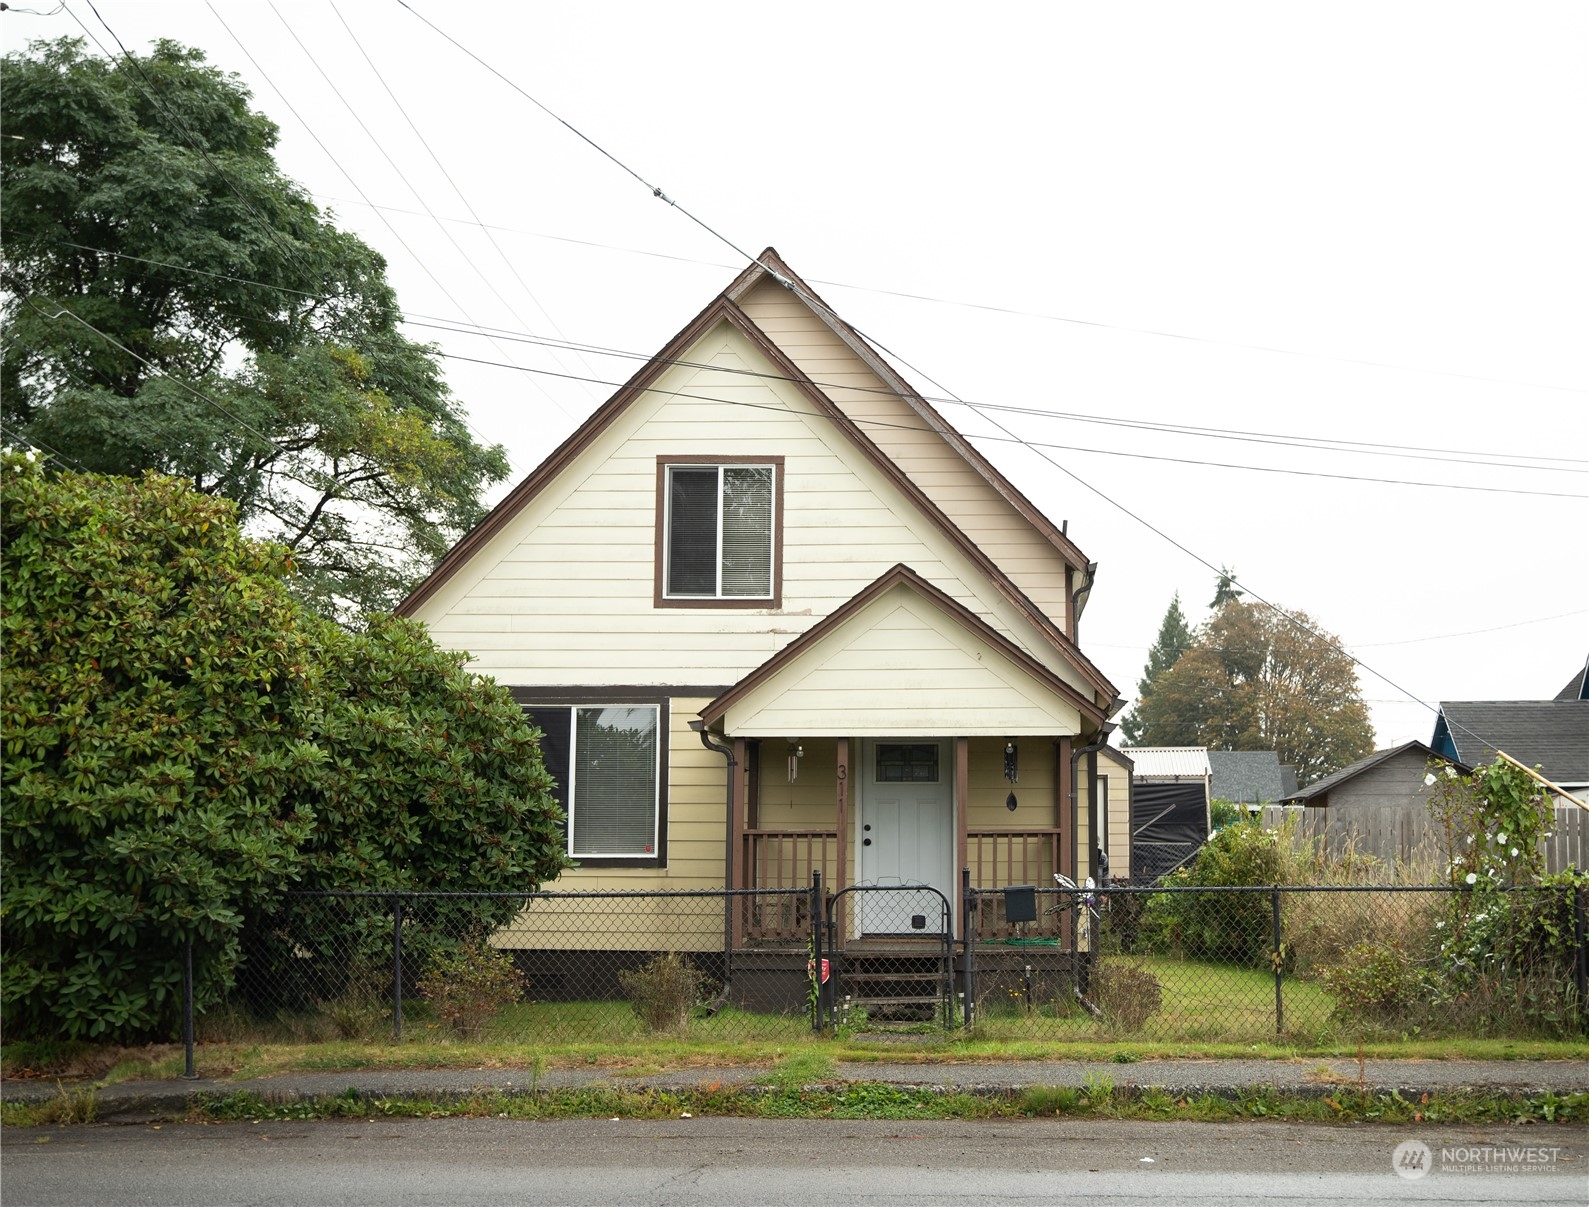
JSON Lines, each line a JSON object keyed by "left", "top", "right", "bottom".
{"left": 199, "top": 886, "right": 1589, "bottom": 1045}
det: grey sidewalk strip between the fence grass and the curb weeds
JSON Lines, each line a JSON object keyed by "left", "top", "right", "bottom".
{"left": 0, "top": 1058, "right": 1589, "bottom": 1121}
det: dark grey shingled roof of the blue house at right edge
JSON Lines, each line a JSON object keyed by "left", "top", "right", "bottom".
{"left": 1430, "top": 700, "right": 1589, "bottom": 785}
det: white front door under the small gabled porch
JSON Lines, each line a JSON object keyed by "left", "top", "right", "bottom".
{"left": 855, "top": 738, "right": 955, "bottom": 934}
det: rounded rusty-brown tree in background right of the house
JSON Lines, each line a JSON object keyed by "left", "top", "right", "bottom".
{"left": 1141, "top": 600, "right": 1373, "bottom": 785}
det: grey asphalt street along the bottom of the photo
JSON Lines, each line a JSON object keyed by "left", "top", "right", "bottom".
{"left": 0, "top": 1118, "right": 1589, "bottom": 1207}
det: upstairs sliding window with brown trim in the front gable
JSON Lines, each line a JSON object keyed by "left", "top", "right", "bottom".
{"left": 656, "top": 459, "right": 782, "bottom": 607}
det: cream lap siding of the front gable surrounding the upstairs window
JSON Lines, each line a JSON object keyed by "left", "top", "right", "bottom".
{"left": 423, "top": 337, "right": 1014, "bottom": 684}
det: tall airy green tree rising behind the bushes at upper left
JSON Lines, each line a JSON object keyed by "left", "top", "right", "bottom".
{"left": 0, "top": 40, "right": 507, "bottom": 615}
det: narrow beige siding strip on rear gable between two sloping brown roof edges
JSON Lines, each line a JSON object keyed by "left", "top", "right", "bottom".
{"left": 740, "top": 281, "right": 1069, "bottom": 627}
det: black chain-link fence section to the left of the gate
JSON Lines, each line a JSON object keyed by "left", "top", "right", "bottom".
{"left": 220, "top": 889, "right": 812, "bottom": 1043}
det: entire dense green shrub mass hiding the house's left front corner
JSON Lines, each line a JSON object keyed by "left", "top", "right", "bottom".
{"left": 0, "top": 453, "right": 566, "bottom": 1039}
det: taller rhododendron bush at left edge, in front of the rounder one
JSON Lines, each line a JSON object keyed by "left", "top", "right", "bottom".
{"left": 0, "top": 454, "right": 321, "bottom": 1039}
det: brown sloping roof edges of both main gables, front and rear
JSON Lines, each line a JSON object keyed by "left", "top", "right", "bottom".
{"left": 397, "top": 248, "right": 1122, "bottom": 715}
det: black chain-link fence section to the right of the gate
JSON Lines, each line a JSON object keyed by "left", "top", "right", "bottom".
{"left": 968, "top": 886, "right": 1589, "bottom": 1043}
